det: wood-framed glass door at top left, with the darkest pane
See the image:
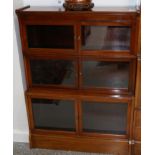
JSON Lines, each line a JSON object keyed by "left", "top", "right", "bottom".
{"left": 23, "top": 20, "right": 77, "bottom": 55}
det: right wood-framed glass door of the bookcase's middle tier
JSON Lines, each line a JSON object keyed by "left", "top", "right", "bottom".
{"left": 80, "top": 56, "right": 136, "bottom": 93}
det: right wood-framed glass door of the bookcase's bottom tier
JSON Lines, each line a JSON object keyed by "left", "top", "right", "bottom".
{"left": 80, "top": 97, "right": 132, "bottom": 138}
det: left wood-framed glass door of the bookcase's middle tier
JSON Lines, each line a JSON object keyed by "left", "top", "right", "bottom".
{"left": 25, "top": 56, "right": 78, "bottom": 88}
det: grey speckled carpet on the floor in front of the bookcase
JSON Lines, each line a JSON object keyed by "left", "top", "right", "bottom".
{"left": 13, "top": 143, "right": 110, "bottom": 155}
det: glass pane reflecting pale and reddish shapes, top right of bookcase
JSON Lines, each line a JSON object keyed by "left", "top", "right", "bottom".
{"left": 81, "top": 26, "right": 130, "bottom": 50}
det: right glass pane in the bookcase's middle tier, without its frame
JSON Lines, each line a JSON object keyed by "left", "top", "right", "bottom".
{"left": 83, "top": 61, "right": 129, "bottom": 88}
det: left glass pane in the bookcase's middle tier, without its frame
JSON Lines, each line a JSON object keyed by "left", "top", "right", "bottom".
{"left": 30, "top": 59, "right": 75, "bottom": 85}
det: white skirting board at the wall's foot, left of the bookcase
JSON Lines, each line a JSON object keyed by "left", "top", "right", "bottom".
{"left": 13, "top": 130, "right": 29, "bottom": 143}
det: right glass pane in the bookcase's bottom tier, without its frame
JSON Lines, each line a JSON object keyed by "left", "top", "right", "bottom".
{"left": 82, "top": 101, "right": 128, "bottom": 134}
